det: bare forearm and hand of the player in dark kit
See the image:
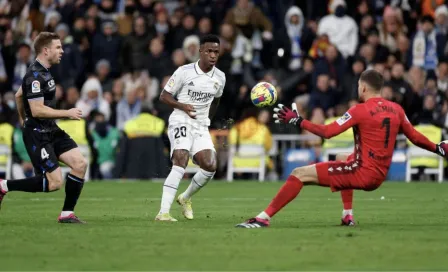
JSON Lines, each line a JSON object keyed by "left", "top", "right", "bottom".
{"left": 28, "top": 98, "right": 82, "bottom": 120}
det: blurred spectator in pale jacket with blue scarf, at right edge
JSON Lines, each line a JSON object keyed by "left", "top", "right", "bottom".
{"left": 411, "top": 16, "right": 446, "bottom": 70}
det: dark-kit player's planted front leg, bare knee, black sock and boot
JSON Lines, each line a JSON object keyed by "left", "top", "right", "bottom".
{"left": 58, "top": 148, "right": 88, "bottom": 223}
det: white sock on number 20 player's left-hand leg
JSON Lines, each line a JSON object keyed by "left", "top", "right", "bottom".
{"left": 159, "top": 165, "right": 185, "bottom": 213}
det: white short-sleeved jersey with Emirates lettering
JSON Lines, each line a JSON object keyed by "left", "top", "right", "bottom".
{"left": 164, "top": 61, "right": 226, "bottom": 127}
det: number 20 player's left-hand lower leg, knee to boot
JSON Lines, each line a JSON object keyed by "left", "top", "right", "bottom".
{"left": 155, "top": 149, "right": 189, "bottom": 222}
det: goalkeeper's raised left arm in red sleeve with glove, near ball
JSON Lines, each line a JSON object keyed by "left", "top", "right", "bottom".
{"left": 274, "top": 103, "right": 356, "bottom": 139}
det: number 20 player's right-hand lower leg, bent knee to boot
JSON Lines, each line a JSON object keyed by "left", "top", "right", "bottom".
{"left": 177, "top": 149, "right": 217, "bottom": 220}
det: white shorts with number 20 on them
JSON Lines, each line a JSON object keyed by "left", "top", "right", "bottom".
{"left": 168, "top": 123, "right": 216, "bottom": 163}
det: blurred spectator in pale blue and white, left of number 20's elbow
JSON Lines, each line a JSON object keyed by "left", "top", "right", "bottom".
{"left": 117, "top": 85, "right": 141, "bottom": 130}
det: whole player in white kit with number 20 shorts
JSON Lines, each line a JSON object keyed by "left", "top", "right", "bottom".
{"left": 156, "top": 35, "right": 226, "bottom": 221}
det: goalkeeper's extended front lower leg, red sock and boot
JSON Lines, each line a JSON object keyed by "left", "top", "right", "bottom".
{"left": 236, "top": 164, "right": 320, "bottom": 228}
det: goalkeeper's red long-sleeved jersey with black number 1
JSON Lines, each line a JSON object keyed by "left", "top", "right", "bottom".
{"left": 301, "top": 98, "right": 436, "bottom": 177}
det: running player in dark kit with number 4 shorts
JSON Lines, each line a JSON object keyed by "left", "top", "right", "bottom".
{"left": 0, "top": 32, "right": 87, "bottom": 223}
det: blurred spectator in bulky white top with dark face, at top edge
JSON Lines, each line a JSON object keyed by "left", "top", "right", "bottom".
{"left": 317, "top": 0, "right": 358, "bottom": 58}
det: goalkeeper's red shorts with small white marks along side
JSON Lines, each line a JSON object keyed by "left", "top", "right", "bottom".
{"left": 316, "top": 154, "right": 384, "bottom": 192}
